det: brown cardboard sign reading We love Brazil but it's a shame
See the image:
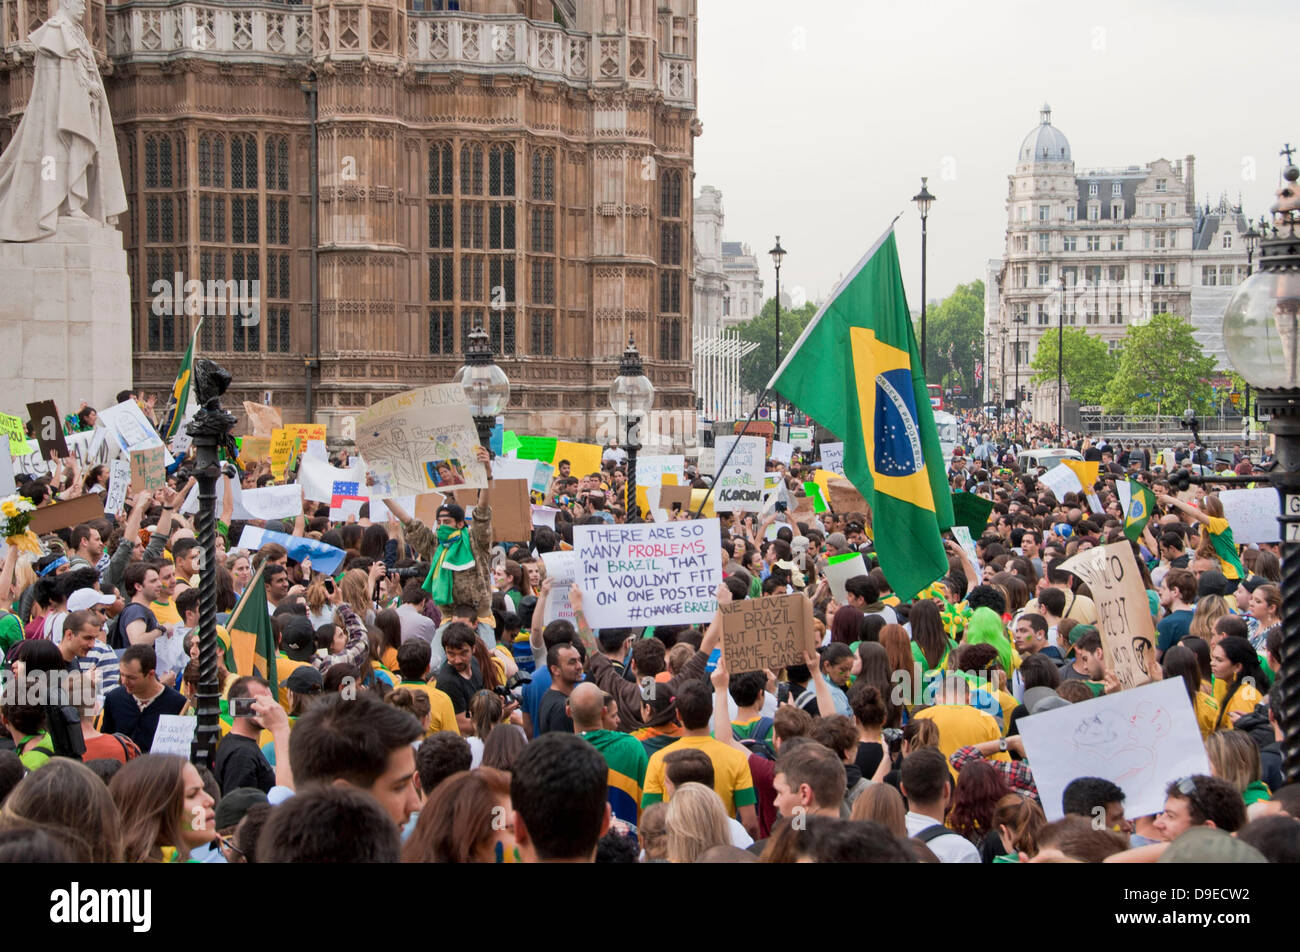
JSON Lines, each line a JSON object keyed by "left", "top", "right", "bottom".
{"left": 722, "top": 594, "right": 818, "bottom": 675}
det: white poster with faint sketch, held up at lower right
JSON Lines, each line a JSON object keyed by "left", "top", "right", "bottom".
{"left": 1017, "top": 681, "right": 1210, "bottom": 819}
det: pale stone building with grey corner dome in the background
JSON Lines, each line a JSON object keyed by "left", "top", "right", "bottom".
{"left": 984, "top": 103, "right": 1245, "bottom": 423}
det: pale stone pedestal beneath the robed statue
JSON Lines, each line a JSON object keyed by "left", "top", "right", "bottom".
{"left": 0, "top": 217, "right": 131, "bottom": 419}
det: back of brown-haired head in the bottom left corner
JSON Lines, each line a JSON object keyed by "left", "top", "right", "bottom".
{"left": 0, "top": 757, "right": 122, "bottom": 862}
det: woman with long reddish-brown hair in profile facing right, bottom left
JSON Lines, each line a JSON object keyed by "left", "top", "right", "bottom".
{"left": 108, "top": 754, "right": 217, "bottom": 862}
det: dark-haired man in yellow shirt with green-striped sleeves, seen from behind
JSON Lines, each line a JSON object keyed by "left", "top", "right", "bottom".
{"left": 639, "top": 676, "right": 758, "bottom": 839}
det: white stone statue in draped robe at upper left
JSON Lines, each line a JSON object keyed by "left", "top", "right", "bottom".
{"left": 0, "top": 0, "right": 126, "bottom": 242}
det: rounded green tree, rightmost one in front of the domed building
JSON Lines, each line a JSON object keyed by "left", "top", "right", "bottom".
{"left": 1101, "top": 313, "right": 1214, "bottom": 416}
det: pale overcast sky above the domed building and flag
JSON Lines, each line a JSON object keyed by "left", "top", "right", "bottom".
{"left": 696, "top": 0, "right": 1300, "bottom": 308}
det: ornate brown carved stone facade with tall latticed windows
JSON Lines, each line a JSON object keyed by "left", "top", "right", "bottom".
{"left": 0, "top": 0, "right": 701, "bottom": 438}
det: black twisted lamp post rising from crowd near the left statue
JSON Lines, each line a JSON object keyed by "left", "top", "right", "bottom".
{"left": 186, "top": 358, "right": 237, "bottom": 770}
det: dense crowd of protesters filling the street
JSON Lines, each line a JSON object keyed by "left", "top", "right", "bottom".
{"left": 0, "top": 392, "right": 1300, "bottom": 864}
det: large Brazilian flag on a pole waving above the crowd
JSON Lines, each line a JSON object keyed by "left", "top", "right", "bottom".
{"left": 768, "top": 228, "right": 953, "bottom": 597}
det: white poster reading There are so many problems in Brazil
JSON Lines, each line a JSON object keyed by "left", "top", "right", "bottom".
{"left": 573, "top": 517, "right": 723, "bottom": 628}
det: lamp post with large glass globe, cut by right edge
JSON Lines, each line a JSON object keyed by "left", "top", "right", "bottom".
{"left": 1223, "top": 154, "right": 1300, "bottom": 783}
